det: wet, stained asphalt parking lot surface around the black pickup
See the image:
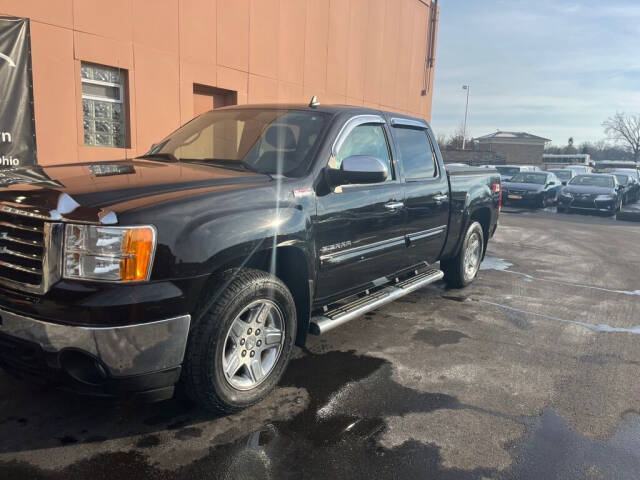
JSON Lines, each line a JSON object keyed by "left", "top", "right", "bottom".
{"left": 0, "top": 209, "right": 640, "bottom": 480}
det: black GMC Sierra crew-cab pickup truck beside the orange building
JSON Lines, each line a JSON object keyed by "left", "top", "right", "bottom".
{"left": 0, "top": 104, "right": 501, "bottom": 412}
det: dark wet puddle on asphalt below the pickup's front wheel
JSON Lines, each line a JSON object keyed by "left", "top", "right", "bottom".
{"left": 0, "top": 351, "right": 492, "bottom": 480}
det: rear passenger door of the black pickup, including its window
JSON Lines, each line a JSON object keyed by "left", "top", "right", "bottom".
{"left": 391, "top": 118, "right": 450, "bottom": 265}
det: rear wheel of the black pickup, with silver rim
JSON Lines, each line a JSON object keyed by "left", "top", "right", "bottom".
{"left": 440, "top": 222, "right": 484, "bottom": 288}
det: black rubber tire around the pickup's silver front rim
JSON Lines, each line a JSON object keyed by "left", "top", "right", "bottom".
{"left": 181, "top": 269, "right": 297, "bottom": 414}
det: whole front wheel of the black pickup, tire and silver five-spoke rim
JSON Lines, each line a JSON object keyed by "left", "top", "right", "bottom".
{"left": 182, "top": 269, "right": 297, "bottom": 413}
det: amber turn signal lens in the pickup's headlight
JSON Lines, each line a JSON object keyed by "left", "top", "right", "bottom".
{"left": 120, "top": 227, "right": 154, "bottom": 282}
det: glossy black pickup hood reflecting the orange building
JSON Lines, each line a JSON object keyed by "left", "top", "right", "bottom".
{"left": 0, "top": 159, "right": 272, "bottom": 223}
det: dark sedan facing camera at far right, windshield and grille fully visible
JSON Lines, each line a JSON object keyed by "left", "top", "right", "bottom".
{"left": 558, "top": 173, "right": 622, "bottom": 213}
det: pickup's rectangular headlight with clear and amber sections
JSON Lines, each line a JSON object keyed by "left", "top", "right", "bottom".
{"left": 63, "top": 224, "right": 156, "bottom": 282}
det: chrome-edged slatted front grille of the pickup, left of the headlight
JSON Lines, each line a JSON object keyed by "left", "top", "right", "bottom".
{"left": 0, "top": 203, "right": 62, "bottom": 293}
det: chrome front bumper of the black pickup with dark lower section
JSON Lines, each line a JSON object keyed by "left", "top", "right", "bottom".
{"left": 0, "top": 309, "right": 191, "bottom": 397}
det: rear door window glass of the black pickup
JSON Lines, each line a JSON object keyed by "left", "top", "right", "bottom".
{"left": 393, "top": 128, "right": 436, "bottom": 180}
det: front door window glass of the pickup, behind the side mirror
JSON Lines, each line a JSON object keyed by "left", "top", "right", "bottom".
{"left": 329, "top": 124, "right": 394, "bottom": 182}
